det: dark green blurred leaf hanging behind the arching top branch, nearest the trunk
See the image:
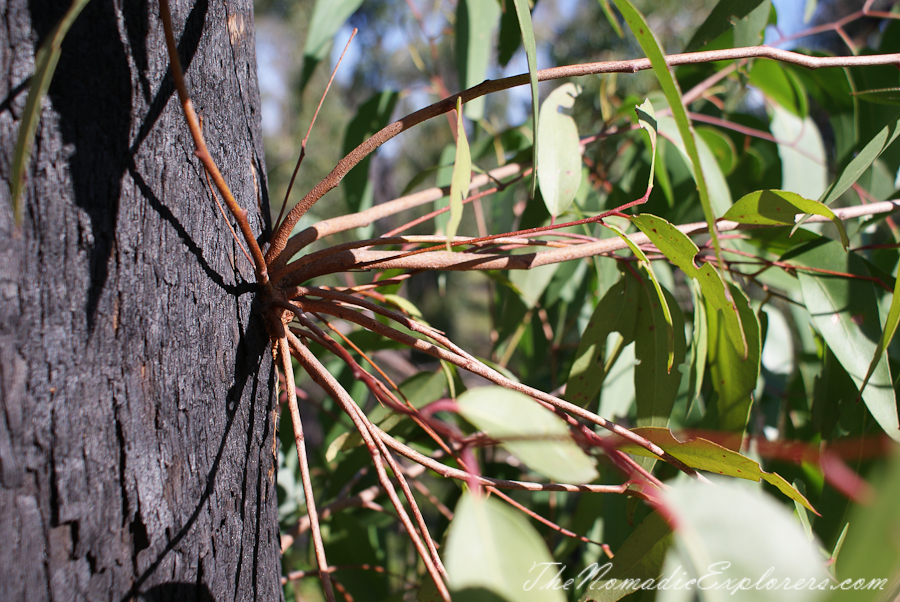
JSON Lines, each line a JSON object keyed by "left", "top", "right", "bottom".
{"left": 341, "top": 90, "right": 400, "bottom": 234}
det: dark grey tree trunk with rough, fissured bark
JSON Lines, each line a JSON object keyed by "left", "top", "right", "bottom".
{"left": 0, "top": 0, "right": 281, "bottom": 602}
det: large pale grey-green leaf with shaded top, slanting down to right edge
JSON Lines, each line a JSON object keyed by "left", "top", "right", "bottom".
{"left": 783, "top": 241, "right": 900, "bottom": 441}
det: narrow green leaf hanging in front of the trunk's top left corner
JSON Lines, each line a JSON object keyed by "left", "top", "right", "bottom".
{"left": 10, "top": 0, "right": 89, "bottom": 226}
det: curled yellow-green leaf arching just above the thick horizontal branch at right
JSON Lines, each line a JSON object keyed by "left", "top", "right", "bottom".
{"left": 722, "top": 190, "right": 850, "bottom": 249}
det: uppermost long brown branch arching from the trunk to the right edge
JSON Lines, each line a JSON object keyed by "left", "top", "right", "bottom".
{"left": 266, "top": 46, "right": 900, "bottom": 267}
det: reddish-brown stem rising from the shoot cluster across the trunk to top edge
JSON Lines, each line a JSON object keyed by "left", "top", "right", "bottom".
{"left": 159, "top": 0, "right": 272, "bottom": 288}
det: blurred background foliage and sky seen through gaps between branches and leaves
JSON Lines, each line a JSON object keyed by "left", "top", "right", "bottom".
{"left": 256, "top": 0, "right": 900, "bottom": 600}
